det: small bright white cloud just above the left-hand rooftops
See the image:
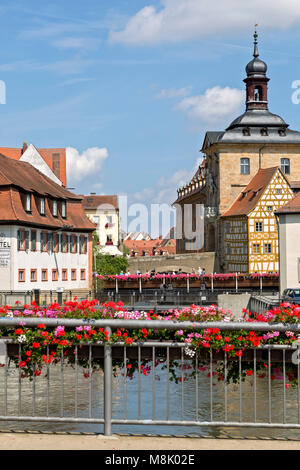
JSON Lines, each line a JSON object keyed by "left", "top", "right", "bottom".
{"left": 66, "top": 147, "right": 108, "bottom": 182}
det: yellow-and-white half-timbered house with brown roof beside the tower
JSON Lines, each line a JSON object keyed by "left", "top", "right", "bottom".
{"left": 222, "top": 167, "right": 293, "bottom": 273}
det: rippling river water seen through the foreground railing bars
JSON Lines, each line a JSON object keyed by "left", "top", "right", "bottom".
{"left": 0, "top": 361, "right": 300, "bottom": 439}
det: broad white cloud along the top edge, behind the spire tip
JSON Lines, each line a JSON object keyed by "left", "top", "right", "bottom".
{"left": 110, "top": 0, "right": 300, "bottom": 45}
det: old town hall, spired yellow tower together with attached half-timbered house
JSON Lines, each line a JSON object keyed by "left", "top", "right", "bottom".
{"left": 174, "top": 32, "right": 300, "bottom": 272}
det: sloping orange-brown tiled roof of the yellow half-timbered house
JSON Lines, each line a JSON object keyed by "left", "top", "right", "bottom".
{"left": 222, "top": 166, "right": 281, "bottom": 217}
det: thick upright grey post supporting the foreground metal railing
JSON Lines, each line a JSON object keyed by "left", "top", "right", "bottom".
{"left": 104, "top": 327, "right": 112, "bottom": 436}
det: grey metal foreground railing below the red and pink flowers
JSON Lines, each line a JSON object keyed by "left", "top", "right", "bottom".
{"left": 0, "top": 317, "right": 300, "bottom": 435}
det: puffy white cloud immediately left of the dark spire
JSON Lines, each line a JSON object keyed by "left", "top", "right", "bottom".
{"left": 176, "top": 86, "right": 245, "bottom": 123}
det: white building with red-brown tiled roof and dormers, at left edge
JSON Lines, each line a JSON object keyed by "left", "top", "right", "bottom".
{"left": 0, "top": 154, "right": 95, "bottom": 295}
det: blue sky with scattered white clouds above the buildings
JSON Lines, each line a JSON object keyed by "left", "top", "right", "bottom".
{"left": 0, "top": 0, "right": 300, "bottom": 235}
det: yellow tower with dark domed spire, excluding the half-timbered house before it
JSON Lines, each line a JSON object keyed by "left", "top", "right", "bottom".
{"left": 176, "top": 32, "right": 300, "bottom": 271}
